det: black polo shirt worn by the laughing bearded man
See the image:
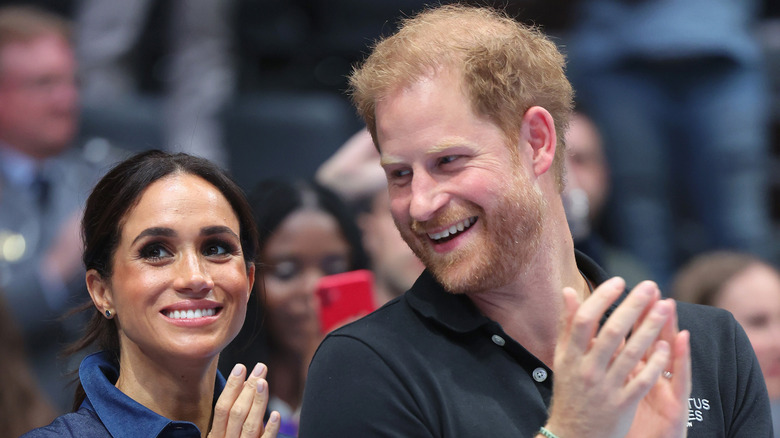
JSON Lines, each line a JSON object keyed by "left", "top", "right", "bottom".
{"left": 300, "top": 254, "right": 772, "bottom": 438}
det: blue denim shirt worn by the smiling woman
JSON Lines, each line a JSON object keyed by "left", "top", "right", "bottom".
{"left": 22, "top": 352, "right": 225, "bottom": 438}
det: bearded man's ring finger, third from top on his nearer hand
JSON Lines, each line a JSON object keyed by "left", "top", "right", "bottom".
{"left": 608, "top": 301, "right": 673, "bottom": 383}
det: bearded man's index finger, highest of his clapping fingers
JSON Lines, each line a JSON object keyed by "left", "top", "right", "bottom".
{"left": 569, "top": 277, "right": 626, "bottom": 351}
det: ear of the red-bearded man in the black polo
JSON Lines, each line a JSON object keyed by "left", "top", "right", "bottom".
{"left": 520, "top": 106, "right": 557, "bottom": 176}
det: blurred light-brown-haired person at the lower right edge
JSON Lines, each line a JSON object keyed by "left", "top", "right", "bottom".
{"left": 672, "top": 251, "right": 780, "bottom": 437}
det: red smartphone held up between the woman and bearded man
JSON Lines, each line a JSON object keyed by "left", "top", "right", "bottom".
{"left": 317, "top": 269, "right": 376, "bottom": 334}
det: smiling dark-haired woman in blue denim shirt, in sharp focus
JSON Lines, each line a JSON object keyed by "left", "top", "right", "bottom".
{"left": 26, "top": 151, "right": 279, "bottom": 438}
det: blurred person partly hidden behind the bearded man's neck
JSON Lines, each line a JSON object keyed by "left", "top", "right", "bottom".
{"left": 563, "top": 111, "right": 649, "bottom": 285}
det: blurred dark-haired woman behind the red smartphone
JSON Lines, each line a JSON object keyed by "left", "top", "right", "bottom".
{"left": 222, "top": 180, "right": 369, "bottom": 435}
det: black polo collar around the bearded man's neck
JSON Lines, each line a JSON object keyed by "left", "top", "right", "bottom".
{"left": 405, "top": 249, "right": 625, "bottom": 333}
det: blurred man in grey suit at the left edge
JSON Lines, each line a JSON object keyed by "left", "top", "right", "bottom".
{"left": 0, "top": 6, "right": 116, "bottom": 410}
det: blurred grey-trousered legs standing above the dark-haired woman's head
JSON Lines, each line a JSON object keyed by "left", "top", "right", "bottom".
{"left": 76, "top": 0, "right": 235, "bottom": 167}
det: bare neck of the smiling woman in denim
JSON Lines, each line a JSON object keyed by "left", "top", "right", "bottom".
{"left": 116, "top": 352, "right": 219, "bottom": 437}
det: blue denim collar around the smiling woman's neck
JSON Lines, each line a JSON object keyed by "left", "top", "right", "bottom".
{"left": 79, "top": 352, "right": 225, "bottom": 438}
